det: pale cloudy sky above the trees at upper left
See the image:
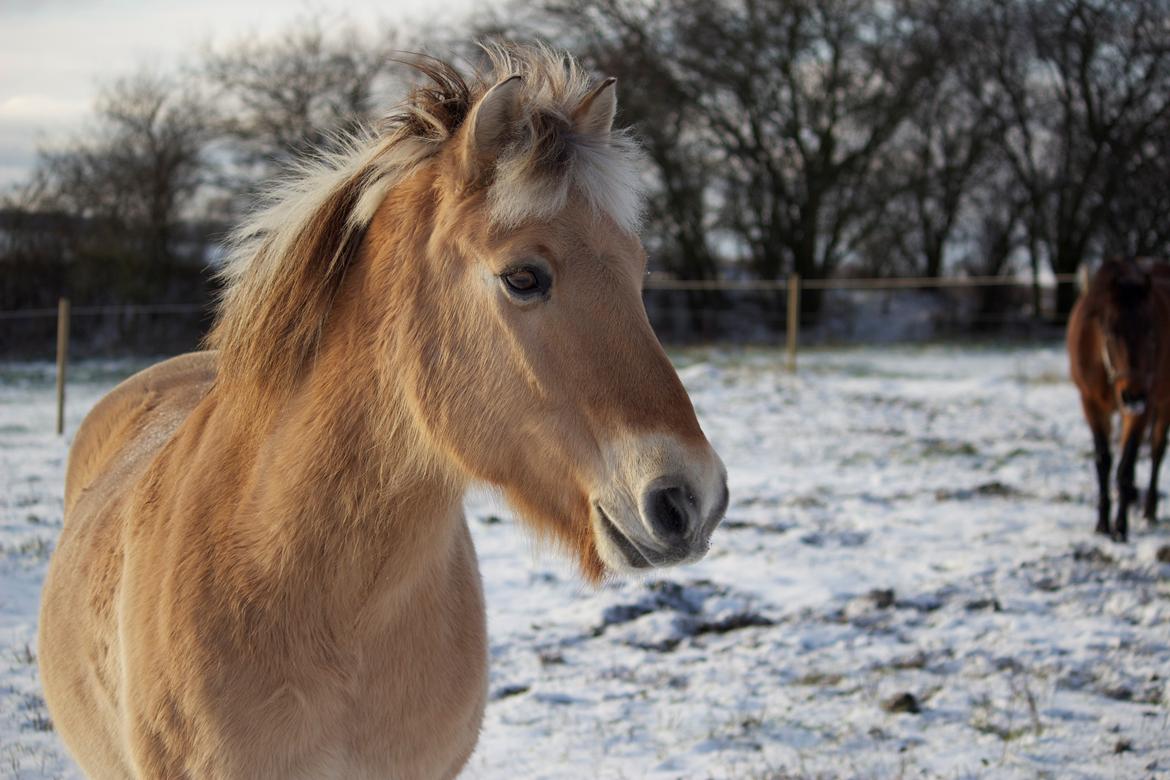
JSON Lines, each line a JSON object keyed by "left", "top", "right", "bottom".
{"left": 0, "top": 0, "right": 479, "bottom": 192}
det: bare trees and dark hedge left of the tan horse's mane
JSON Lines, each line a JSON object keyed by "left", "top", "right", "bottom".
{"left": 0, "top": 16, "right": 404, "bottom": 309}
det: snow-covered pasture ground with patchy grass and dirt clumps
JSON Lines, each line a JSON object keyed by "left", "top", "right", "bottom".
{"left": 0, "top": 347, "right": 1170, "bottom": 779}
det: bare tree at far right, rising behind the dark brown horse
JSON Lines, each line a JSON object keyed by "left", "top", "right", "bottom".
{"left": 970, "top": 0, "right": 1170, "bottom": 316}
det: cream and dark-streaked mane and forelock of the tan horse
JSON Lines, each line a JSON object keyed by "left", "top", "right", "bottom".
{"left": 206, "top": 43, "right": 642, "bottom": 406}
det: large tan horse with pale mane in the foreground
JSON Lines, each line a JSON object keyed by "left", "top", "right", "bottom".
{"left": 40, "top": 48, "right": 728, "bottom": 779}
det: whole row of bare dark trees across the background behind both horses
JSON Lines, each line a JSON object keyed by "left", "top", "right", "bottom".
{"left": 0, "top": 0, "right": 1170, "bottom": 322}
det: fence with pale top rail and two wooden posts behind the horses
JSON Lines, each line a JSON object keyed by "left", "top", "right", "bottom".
{"left": 0, "top": 268, "right": 1088, "bottom": 434}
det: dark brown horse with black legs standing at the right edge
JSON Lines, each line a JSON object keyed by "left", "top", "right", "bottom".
{"left": 1068, "top": 260, "right": 1170, "bottom": 541}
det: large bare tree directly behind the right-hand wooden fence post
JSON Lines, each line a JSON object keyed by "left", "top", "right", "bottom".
{"left": 673, "top": 0, "right": 931, "bottom": 294}
